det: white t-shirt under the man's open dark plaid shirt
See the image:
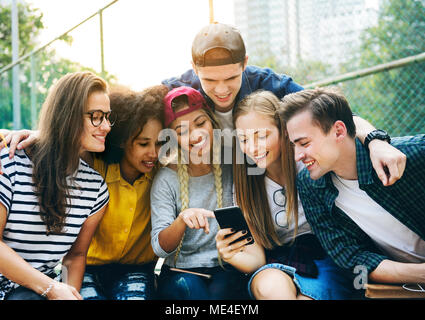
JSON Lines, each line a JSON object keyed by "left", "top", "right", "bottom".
{"left": 332, "top": 174, "right": 425, "bottom": 263}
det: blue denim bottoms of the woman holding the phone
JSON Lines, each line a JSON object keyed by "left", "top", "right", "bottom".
{"left": 248, "top": 256, "right": 357, "bottom": 300}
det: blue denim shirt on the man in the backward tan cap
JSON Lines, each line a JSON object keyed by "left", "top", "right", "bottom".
{"left": 162, "top": 66, "right": 303, "bottom": 109}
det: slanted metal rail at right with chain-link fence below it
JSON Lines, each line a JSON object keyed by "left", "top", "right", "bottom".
{"left": 304, "top": 52, "right": 425, "bottom": 136}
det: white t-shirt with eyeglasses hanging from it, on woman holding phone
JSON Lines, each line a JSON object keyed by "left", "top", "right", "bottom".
{"left": 264, "top": 162, "right": 312, "bottom": 243}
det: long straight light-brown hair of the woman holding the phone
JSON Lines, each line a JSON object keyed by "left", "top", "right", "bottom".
{"left": 233, "top": 91, "right": 298, "bottom": 249}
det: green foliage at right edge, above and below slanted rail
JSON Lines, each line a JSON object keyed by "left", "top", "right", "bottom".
{"left": 344, "top": 0, "right": 425, "bottom": 135}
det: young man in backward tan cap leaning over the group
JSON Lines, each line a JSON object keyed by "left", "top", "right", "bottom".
{"left": 162, "top": 23, "right": 406, "bottom": 185}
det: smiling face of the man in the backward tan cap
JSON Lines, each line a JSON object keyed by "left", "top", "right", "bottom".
{"left": 193, "top": 60, "right": 247, "bottom": 112}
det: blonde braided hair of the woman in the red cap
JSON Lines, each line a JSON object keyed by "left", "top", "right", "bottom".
{"left": 167, "top": 95, "right": 223, "bottom": 265}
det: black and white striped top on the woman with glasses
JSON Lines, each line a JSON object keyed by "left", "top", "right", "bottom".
{"left": 0, "top": 149, "right": 109, "bottom": 300}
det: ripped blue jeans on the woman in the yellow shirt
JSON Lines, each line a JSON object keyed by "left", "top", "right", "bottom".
{"left": 80, "top": 263, "right": 155, "bottom": 300}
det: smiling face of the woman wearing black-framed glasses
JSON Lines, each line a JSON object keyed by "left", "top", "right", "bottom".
{"left": 80, "top": 91, "right": 111, "bottom": 154}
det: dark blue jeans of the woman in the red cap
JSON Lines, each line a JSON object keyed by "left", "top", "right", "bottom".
{"left": 158, "top": 265, "right": 249, "bottom": 300}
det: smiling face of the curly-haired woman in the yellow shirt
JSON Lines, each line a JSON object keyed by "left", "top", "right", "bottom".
{"left": 120, "top": 119, "right": 162, "bottom": 182}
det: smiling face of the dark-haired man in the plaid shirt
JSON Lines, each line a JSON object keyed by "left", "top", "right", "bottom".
{"left": 286, "top": 111, "right": 340, "bottom": 180}
